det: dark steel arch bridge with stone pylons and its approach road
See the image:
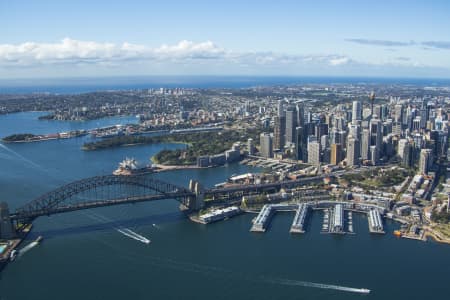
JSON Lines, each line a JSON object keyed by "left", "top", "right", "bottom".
{"left": 0, "top": 174, "right": 325, "bottom": 238}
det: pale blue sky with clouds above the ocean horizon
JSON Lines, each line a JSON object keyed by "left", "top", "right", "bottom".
{"left": 0, "top": 0, "right": 450, "bottom": 78}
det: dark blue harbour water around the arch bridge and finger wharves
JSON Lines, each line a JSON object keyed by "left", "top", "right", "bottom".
{"left": 0, "top": 113, "right": 450, "bottom": 300}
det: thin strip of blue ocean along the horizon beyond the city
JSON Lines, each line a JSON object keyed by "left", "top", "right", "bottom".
{"left": 0, "top": 76, "right": 450, "bottom": 94}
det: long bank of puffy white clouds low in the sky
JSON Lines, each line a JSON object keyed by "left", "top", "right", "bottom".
{"left": 0, "top": 38, "right": 350, "bottom": 66}
